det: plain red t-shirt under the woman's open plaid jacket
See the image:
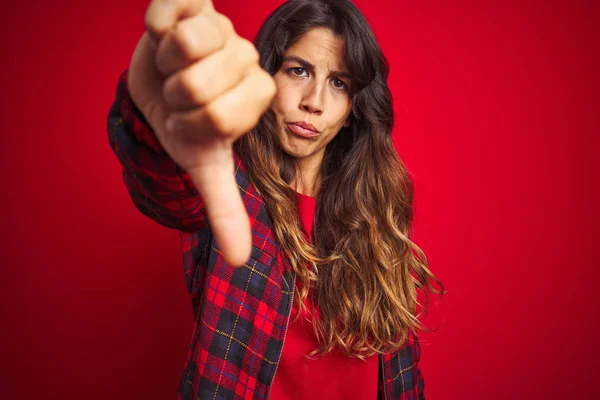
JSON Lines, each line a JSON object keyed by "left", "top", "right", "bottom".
{"left": 270, "top": 193, "right": 379, "bottom": 400}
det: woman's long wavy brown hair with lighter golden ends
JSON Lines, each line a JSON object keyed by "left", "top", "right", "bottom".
{"left": 235, "top": 0, "right": 444, "bottom": 359}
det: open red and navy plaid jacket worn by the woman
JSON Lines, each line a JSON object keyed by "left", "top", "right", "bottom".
{"left": 107, "top": 72, "right": 425, "bottom": 400}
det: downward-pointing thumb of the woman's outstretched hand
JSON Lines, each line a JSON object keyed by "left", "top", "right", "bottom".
{"left": 187, "top": 141, "right": 252, "bottom": 267}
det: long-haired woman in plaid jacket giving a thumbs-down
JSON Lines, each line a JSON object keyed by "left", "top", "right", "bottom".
{"left": 108, "top": 0, "right": 443, "bottom": 400}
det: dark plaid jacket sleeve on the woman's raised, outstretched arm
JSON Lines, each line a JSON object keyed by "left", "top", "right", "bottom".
{"left": 107, "top": 71, "right": 207, "bottom": 232}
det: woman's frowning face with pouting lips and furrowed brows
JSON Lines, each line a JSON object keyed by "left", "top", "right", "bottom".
{"left": 271, "top": 28, "right": 352, "bottom": 168}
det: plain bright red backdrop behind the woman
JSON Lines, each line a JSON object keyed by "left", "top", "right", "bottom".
{"left": 0, "top": 0, "right": 600, "bottom": 400}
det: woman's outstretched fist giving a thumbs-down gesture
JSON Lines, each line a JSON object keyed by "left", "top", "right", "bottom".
{"left": 128, "top": 0, "right": 276, "bottom": 266}
